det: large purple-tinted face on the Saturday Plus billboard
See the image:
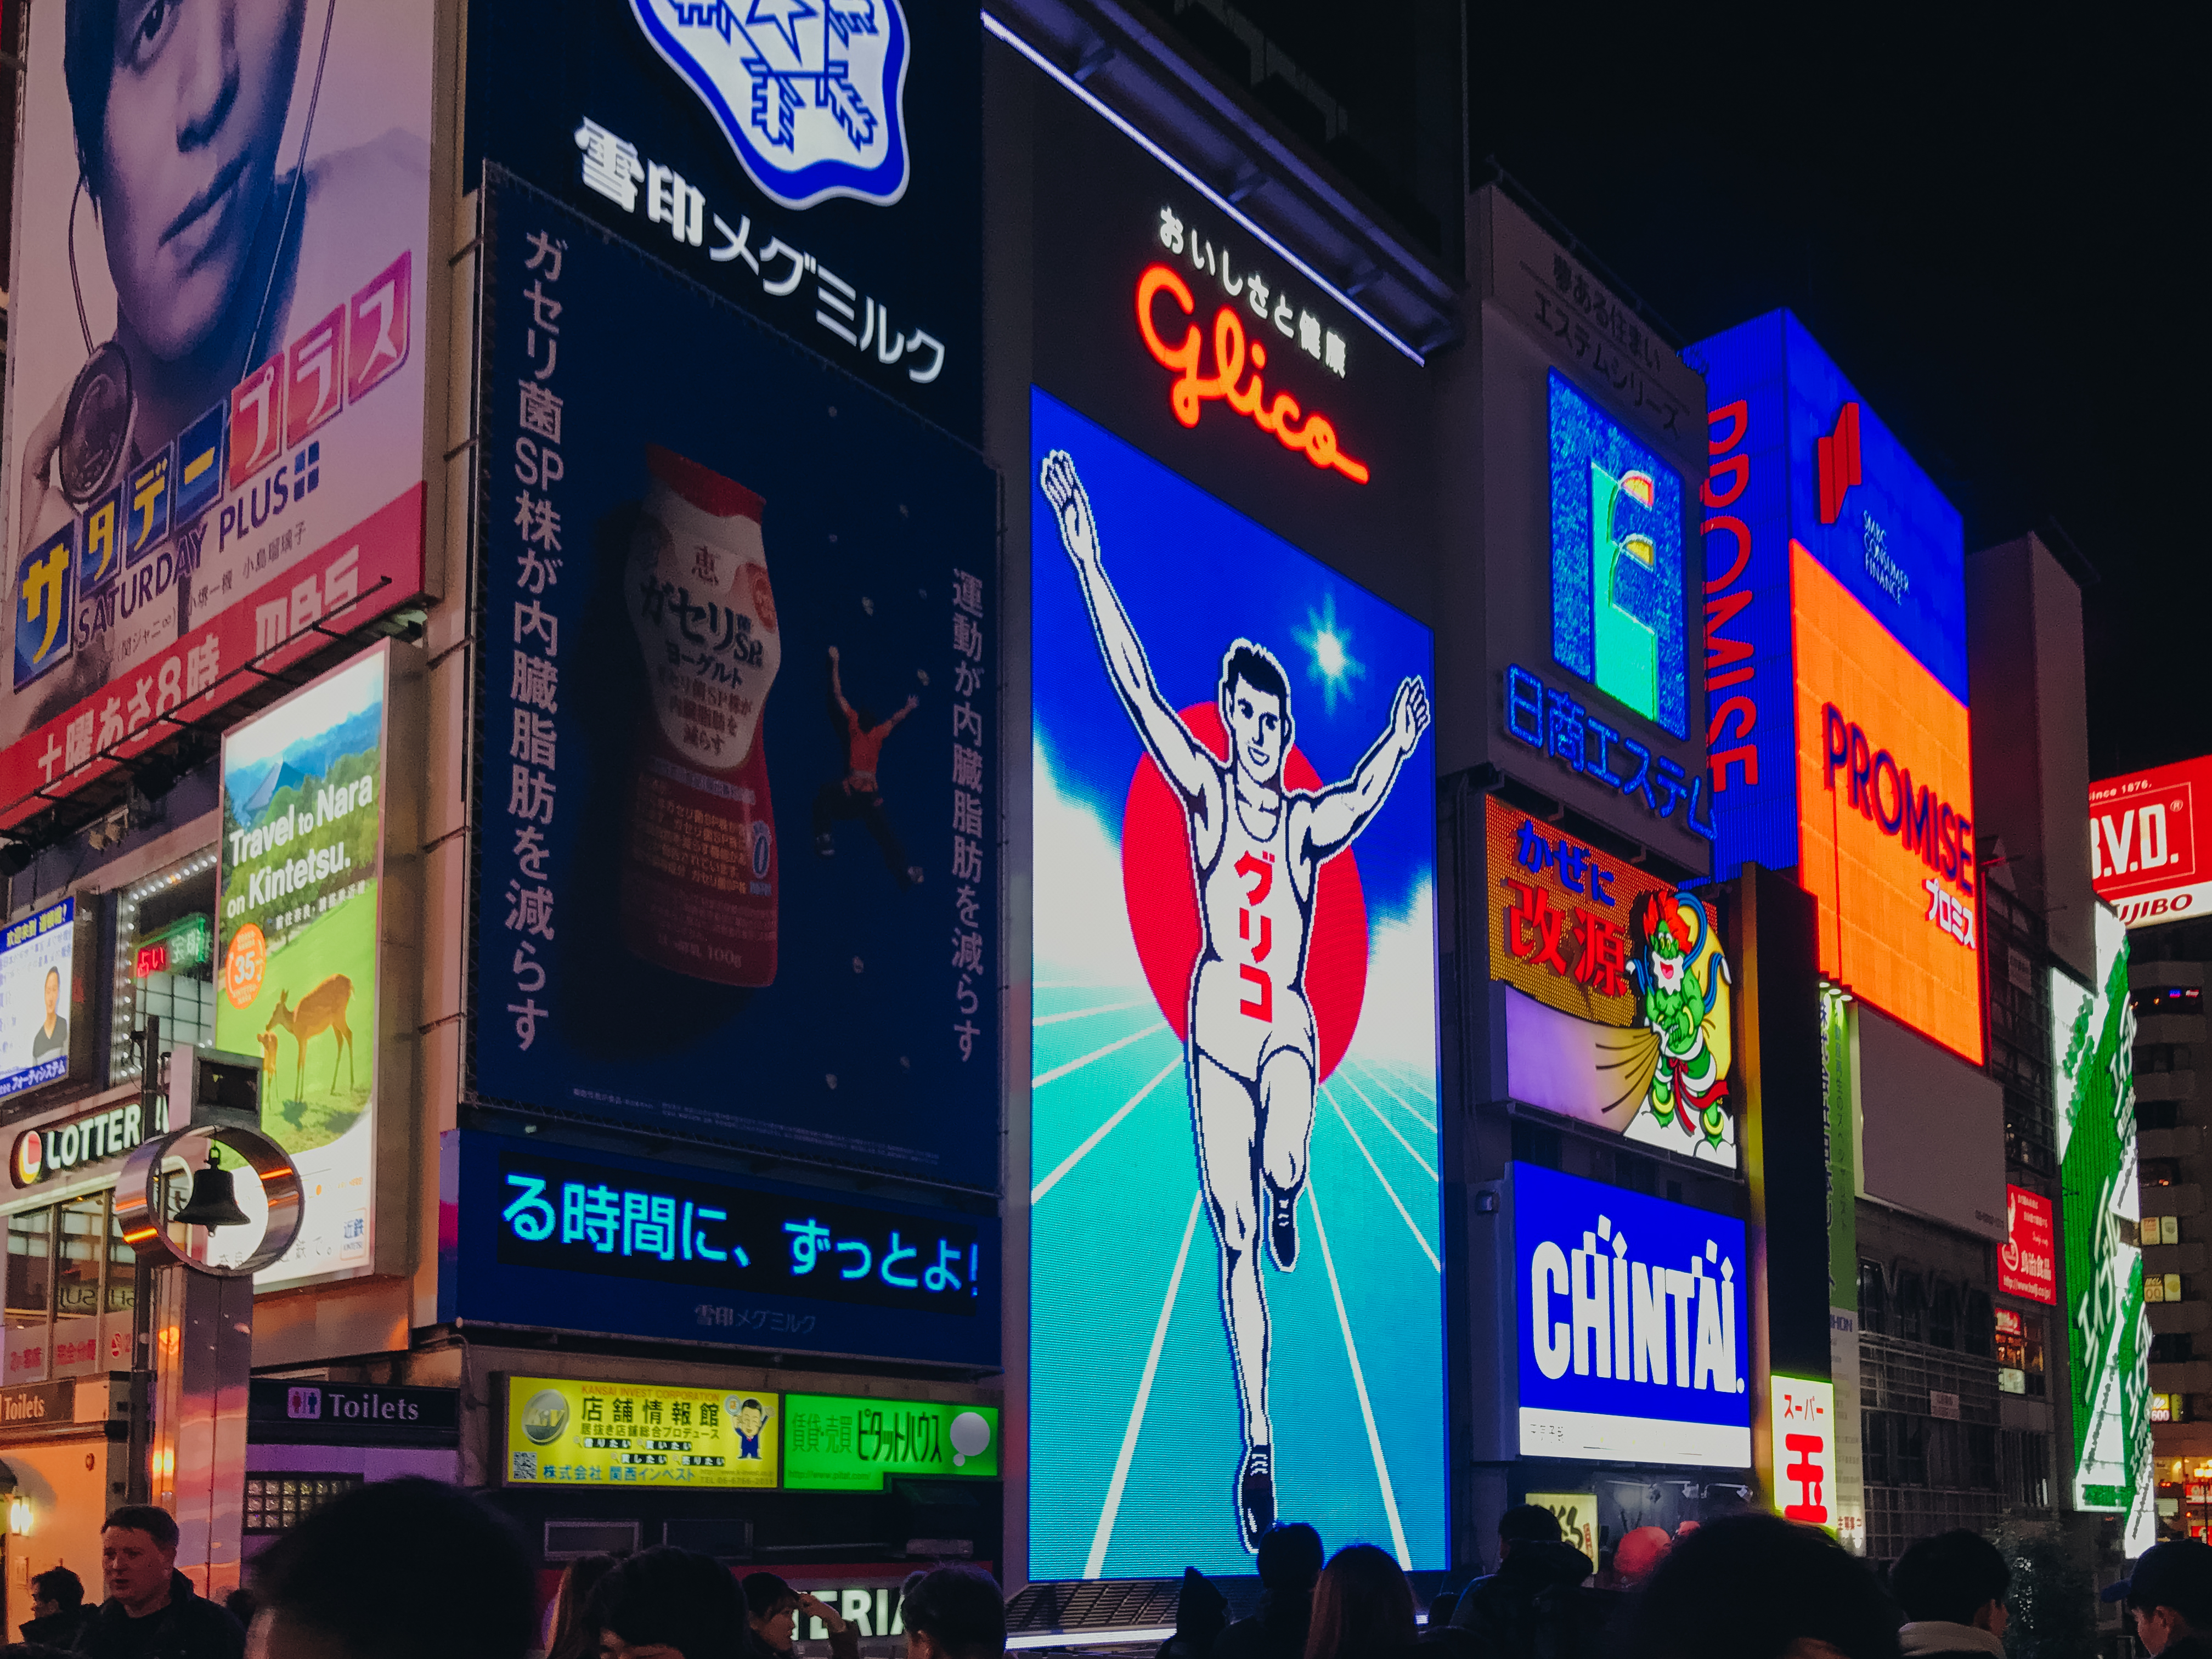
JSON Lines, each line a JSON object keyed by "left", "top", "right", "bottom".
{"left": 95, "top": 0, "right": 307, "bottom": 360}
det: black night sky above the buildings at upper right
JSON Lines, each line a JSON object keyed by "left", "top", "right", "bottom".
{"left": 1221, "top": 0, "right": 2212, "bottom": 776}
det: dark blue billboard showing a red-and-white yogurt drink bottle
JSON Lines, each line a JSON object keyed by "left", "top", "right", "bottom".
{"left": 473, "top": 181, "right": 1000, "bottom": 1190}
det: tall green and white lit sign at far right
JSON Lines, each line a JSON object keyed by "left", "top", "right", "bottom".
{"left": 2051, "top": 905, "right": 2157, "bottom": 1553}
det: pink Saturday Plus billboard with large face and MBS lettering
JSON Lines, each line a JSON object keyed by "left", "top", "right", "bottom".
{"left": 0, "top": 0, "right": 433, "bottom": 823}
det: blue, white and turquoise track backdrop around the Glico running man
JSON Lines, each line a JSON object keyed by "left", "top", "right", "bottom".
{"left": 1029, "top": 392, "right": 1447, "bottom": 1579}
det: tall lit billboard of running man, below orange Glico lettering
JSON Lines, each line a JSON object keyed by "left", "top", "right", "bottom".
{"left": 1029, "top": 392, "right": 1447, "bottom": 1579}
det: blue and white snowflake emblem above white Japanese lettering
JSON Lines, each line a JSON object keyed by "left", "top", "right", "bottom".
{"left": 630, "top": 0, "right": 911, "bottom": 208}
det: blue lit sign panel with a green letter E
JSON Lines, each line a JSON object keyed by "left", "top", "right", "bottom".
{"left": 1550, "top": 380, "right": 1690, "bottom": 737}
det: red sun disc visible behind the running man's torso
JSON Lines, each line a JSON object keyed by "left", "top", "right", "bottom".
{"left": 1121, "top": 703, "right": 1367, "bottom": 1082}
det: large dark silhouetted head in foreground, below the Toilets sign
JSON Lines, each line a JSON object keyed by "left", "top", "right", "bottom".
{"left": 248, "top": 1475, "right": 538, "bottom": 1659}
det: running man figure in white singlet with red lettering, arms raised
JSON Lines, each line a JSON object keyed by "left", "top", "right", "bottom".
{"left": 1040, "top": 449, "right": 1429, "bottom": 1550}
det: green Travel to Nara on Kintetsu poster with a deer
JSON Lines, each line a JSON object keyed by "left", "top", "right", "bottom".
{"left": 215, "top": 646, "right": 392, "bottom": 1288}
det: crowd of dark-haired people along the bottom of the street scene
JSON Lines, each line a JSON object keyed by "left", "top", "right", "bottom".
{"left": 17, "top": 1477, "right": 2212, "bottom": 1659}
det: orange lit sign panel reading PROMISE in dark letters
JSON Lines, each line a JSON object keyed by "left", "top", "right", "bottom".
{"left": 1790, "top": 542, "right": 1982, "bottom": 1066}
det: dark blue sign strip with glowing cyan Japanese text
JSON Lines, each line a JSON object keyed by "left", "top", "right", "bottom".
{"left": 438, "top": 1130, "right": 1002, "bottom": 1369}
